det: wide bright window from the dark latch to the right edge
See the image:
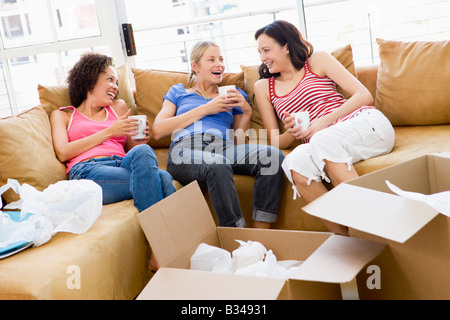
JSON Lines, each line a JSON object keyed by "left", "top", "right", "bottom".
{"left": 123, "top": 0, "right": 450, "bottom": 71}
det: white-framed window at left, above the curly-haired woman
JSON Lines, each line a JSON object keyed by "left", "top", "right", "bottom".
{"left": 0, "top": 0, "right": 121, "bottom": 117}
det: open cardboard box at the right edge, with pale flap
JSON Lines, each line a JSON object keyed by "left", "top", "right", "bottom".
{"left": 303, "top": 154, "right": 450, "bottom": 299}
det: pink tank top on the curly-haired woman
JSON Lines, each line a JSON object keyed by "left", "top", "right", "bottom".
{"left": 59, "top": 107, "right": 127, "bottom": 173}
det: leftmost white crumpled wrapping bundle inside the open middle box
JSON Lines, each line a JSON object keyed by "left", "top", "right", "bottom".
{"left": 191, "top": 243, "right": 233, "bottom": 273}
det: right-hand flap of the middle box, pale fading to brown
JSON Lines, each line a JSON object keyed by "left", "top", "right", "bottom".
{"left": 291, "top": 235, "right": 386, "bottom": 283}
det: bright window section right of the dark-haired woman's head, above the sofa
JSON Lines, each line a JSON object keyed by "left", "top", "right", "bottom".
{"left": 304, "top": 0, "right": 450, "bottom": 64}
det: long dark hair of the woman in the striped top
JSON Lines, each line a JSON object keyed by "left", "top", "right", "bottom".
{"left": 255, "top": 20, "right": 314, "bottom": 79}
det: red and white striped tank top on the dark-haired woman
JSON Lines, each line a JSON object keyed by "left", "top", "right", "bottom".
{"left": 269, "top": 60, "right": 375, "bottom": 124}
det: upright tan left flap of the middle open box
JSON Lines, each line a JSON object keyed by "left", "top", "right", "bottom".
{"left": 138, "top": 182, "right": 216, "bottom": 267}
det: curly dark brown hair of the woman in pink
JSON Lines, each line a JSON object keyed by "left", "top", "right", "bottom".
{"left": 67, "top": 52, "right": 114, "bottom": 108}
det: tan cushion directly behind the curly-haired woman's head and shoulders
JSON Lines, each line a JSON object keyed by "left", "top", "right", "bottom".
{"left": 38, "top": 64, "right": 136, "bottom": 116}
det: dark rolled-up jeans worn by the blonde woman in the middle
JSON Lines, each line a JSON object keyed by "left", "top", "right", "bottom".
{"left": 167, "top": 134, "right": 284, "bottom": 227}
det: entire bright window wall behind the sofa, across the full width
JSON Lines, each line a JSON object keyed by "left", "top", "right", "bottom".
{"left": 0, "top": 0, "right": 450, "bottom": 117}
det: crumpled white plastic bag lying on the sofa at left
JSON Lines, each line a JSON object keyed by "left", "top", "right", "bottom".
{"left": 0, "top": 179, "right": 103, "bottom": 248}
